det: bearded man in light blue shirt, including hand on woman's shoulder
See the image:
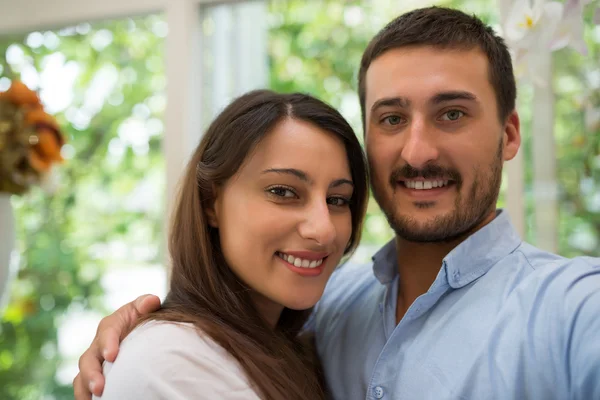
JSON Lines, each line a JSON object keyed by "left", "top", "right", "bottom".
{"left": 74, "top": 7, "right": 600, "bottom": 400}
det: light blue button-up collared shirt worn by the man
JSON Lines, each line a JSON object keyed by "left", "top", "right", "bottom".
{"left": 313, "top": 211, "right": 600, "bottom": 400}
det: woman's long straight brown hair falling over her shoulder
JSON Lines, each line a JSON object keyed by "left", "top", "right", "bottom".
{"left": 145, "top": 90, "right": 368, "bottom": 400}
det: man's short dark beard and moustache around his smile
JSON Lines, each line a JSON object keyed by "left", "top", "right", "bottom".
{"left": 371, "top": 140, "right": 503, "bottom": 243}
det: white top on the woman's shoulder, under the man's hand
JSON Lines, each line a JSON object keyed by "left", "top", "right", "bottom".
{"left": 94, "top": 321, "right": 259, "bottom": 400}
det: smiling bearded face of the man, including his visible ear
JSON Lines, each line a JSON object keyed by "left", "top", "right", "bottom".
{"left": 365, "top": 46, "right": 520, "bottom": 242}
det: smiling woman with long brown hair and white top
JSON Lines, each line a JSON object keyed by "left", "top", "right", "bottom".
{"left": 94, "top": 90, "right": 368, "bottom": 400}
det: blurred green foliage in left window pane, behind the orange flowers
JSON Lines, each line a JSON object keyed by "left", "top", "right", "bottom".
{"left": 0, "top": 16, "right": 166, "bottom": 400}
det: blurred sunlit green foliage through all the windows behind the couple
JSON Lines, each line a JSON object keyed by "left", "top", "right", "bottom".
{"left": 0, "top": 0, "right": 600, "bottom": 400}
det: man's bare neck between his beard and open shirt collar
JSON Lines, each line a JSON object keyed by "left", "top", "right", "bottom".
{"left": 396, "top": 209, "right": 496, "bottom": 323}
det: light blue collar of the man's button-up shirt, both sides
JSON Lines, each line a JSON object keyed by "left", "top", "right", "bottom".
{"left": 373, "top": 210, "right": 521, "bottom": 289}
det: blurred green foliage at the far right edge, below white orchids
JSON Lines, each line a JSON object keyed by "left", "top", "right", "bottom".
{"left": 552, "top": 0, "right": 600, "bottom": 257}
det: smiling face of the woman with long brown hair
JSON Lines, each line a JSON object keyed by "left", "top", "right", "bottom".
{"left": 209, "top": 119, "right": 353, "bottom": 323}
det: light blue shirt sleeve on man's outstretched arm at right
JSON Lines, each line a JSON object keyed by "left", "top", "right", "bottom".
{"left": 454, "top": 258, "right": 600, "bottom": 400}
